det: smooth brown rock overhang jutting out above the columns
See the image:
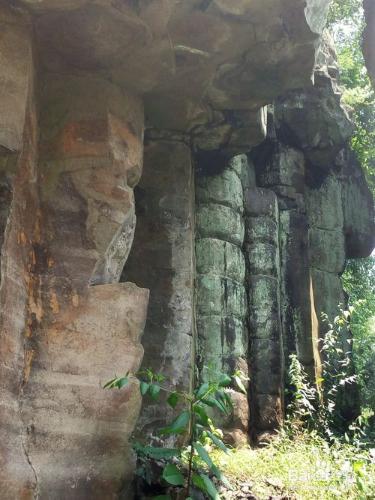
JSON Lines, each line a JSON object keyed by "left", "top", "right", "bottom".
{"left": 16, "top": 0, "right": 329, "bottom": 144}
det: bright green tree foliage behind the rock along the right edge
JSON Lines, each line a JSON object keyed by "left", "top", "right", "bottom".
{"left": 329, "top": 0, "right": 375, "bottom": 434}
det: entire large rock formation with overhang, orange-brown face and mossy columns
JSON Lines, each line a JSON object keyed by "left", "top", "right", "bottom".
{"left": 0, "top": 0, "right": 373, "bottom": 500}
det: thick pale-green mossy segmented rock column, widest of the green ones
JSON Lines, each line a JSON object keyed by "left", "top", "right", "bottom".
{"left": 195, "top": 156, "right": 248, "bottom": 442}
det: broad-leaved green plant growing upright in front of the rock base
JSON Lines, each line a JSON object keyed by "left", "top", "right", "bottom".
{"left": 104, "top": 369, "right": 246, "bottom": 500}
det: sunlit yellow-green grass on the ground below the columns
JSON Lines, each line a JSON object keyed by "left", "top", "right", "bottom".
{"left": 214, "top": 434, "right": 375, "bottom": 500}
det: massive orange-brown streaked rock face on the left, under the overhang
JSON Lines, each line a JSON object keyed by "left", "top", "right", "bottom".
{"left": 0, "top": 3, "right": 148, "bottom": 499}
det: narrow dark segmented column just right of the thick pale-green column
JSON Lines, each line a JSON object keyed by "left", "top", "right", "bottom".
{"left": 245, "top": 179, "right": 283, "bottom": 433}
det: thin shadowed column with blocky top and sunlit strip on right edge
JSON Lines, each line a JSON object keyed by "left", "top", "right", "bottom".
{"left": 254, "top": 145, "right": 316, "bottom": 380}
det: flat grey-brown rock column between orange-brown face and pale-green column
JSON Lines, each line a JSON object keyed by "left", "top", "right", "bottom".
{"left": 123, "top": 137, "right": 194, "bottom": 433}
